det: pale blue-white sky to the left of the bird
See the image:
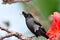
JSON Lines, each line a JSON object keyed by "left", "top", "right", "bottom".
{"left": 0, "top": 0, "right": 32, "bottom": 40}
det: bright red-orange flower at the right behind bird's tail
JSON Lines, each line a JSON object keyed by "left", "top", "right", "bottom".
{"left": 46, "top": 12, "right": 60, "bottom": 40}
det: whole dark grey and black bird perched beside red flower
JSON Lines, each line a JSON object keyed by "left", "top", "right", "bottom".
{"left": 22, "top": 12, "right": 49, "bottom": 39}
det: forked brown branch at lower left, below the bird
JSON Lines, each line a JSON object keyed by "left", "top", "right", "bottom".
{"left": 0, "top": 27, "right": 35, "bottom": 40}
